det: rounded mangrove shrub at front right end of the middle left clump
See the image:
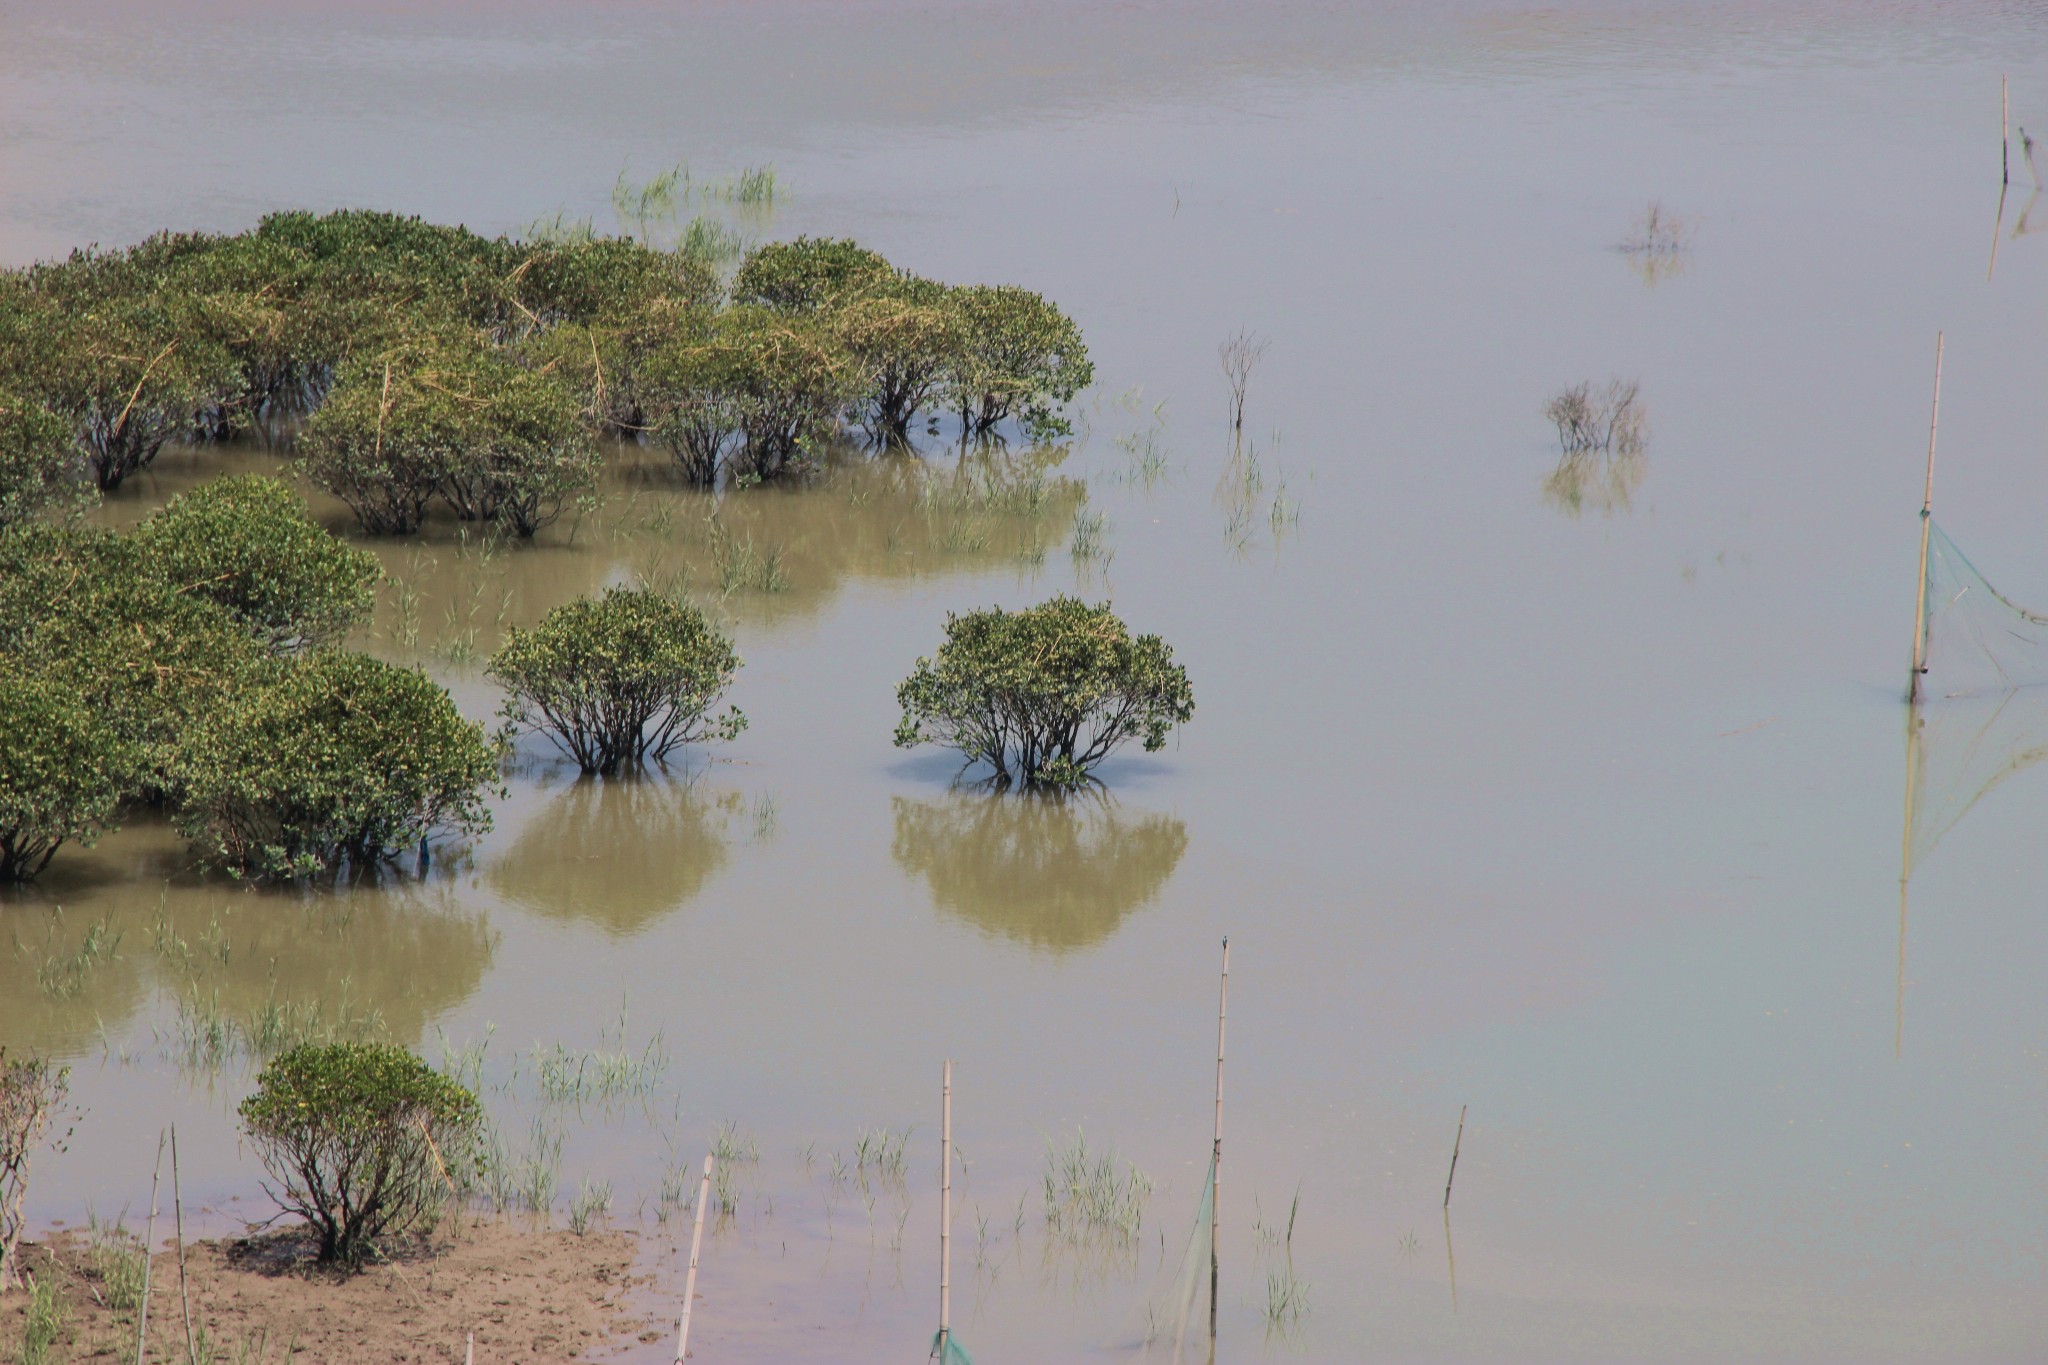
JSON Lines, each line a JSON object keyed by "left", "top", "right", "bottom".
{"left": 176, "top": 651, "right": 498, "bottom": 880}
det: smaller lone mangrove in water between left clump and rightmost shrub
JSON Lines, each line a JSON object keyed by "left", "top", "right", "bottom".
{"left": 489, "top": 587, "right": 748, "bottom": 776}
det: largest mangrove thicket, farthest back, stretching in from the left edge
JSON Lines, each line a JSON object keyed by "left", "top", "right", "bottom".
{"left": 0, "top": 210, "right": 1094, "bottom": 519}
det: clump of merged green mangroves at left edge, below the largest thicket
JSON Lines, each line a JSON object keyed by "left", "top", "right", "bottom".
{"left": 0, "top": 505, "right": 475, "bottom": 880}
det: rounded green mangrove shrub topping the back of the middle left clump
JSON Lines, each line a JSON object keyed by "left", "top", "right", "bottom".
{"left": 135, "top": 475, "right": 383, "bottom": 653}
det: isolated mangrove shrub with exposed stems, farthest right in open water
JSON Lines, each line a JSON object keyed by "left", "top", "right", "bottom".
{"left": 895, "top": 596, "right": 1194, "bottom": 788}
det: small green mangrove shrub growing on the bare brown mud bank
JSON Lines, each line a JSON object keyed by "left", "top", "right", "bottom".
{"left": 240, "top": 1044, "right": 483, "bottom": 1265}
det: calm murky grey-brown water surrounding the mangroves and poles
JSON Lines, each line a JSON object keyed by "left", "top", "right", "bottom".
{"left": 0, "top": 0, "right": 2048, "bottom": 1361}
